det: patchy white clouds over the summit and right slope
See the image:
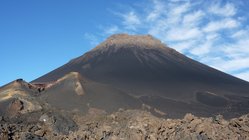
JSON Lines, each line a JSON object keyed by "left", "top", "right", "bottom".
{"left": 84, "top": 0, "right": 249, "bottom": 81}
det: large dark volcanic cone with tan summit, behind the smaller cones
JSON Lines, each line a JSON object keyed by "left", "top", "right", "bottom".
{"left": 34, "top": 34, "right": 249, "bottom": 117}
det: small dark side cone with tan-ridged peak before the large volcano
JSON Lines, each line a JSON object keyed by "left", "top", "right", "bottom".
{"left": 40, "top": 72, "right": 142, "bottom": 114}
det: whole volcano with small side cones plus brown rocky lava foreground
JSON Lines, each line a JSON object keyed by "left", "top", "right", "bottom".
{"left": 0, "top": 34, "right": 249, "bottom": 140}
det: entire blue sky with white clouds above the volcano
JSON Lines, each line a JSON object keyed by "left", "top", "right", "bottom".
{"left": 0, "top": 0, "right": 249, "bottom": 86}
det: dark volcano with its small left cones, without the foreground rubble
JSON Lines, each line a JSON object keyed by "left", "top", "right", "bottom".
{"left": 0, "top": 34, "right": 249, "bottom": 118}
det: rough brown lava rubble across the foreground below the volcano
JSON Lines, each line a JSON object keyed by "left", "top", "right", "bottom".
{"left": 0, "top": 109, "right": 249, "bottom": 140}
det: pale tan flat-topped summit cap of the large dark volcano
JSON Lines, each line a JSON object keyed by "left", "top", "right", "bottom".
{"left": 93, "top": 34, "right": 166, "bottom": 50}
